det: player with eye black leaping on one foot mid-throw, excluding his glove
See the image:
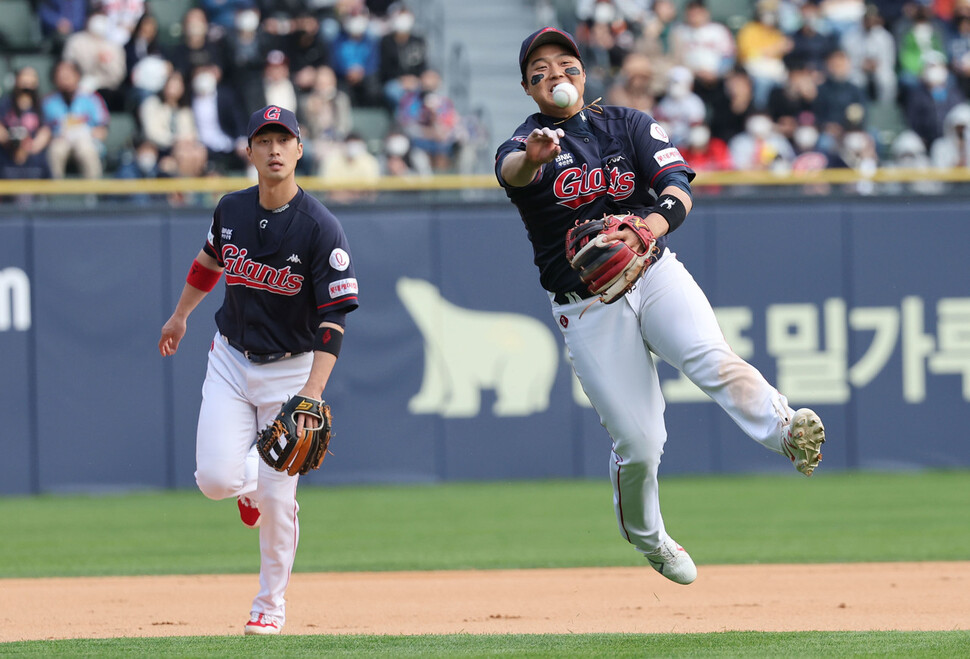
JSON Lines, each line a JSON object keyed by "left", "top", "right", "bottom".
{"left": 495, "top": 27, "right": 825, "bottom": 584}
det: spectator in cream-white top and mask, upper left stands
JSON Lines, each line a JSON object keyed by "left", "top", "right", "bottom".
{"left": 63, "top": 11, "right": 128, "bottom": 112}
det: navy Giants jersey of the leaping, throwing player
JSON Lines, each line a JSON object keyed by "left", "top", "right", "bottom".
{"left": 495, "top": 106, "right": 694, "bottom": 296}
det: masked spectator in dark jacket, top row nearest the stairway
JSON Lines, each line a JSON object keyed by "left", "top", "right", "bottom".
{"left": 380, "top": 5, "right": 428, "bottom": 112}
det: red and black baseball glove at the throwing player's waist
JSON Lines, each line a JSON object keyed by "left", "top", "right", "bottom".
{"left": 566, "top": 214, "right": 660, "bottom": 304}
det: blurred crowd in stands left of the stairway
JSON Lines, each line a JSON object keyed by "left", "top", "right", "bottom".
{"left": 0, "top": 0, "right": 482, "bottom": 199}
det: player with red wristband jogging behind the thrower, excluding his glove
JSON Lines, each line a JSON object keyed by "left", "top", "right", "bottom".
{"left": 158, "top": 106, "right": 357, "bottom": 634}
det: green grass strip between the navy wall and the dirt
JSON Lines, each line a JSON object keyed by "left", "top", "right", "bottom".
{"left": 0, "top": 471, "right": 970, "bottom": 577}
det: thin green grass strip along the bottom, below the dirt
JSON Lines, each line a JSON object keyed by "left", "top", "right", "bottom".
{"left": 0, "top": 632, "right": 970, "bottom": 657}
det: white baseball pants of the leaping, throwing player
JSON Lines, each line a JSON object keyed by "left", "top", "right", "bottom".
{"left": 550, "top": 250, "right": 794, "bottom": 553}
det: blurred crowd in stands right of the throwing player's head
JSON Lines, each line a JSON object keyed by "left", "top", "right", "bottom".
{"left": 537, "top": 0, "right": 970, "bottom": 188}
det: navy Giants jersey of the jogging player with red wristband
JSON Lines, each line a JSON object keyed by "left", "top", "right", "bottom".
{"left": 203, "top": 186, "right": 357, "bottom": 353}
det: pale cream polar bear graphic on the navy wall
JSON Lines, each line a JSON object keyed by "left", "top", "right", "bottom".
{"left": 397, "top": 277, "right": 559, "bottom": 418}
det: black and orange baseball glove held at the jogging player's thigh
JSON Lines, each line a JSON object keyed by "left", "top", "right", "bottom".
{"left": 256, "top": 396, "right": 332, "bottom": 476}
